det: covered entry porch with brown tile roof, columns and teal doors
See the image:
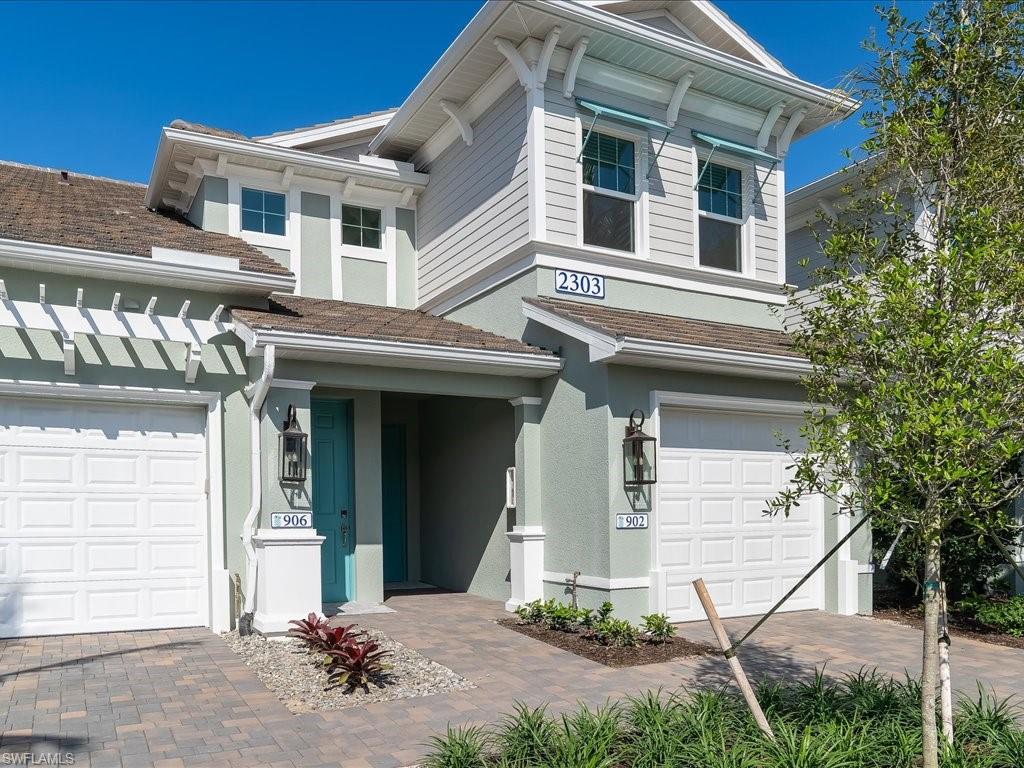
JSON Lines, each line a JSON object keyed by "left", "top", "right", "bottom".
{"left": 236, "top": 297, "right": 560, "bottom": 634}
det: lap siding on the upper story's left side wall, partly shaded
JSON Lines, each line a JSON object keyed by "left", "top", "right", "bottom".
{"left": 418, "top": 86, "right": 529, "bottom": 300}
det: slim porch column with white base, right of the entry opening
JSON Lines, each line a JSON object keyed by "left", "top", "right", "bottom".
{"left": 505, "top": 397, "right": 544, "bottom": 610}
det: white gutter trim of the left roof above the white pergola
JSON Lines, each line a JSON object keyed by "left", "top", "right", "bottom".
{"left": 0, "top": 238, "right": 295, "bottom": 295}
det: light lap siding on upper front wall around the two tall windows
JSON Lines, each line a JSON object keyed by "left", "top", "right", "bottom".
{"left": 545, "top": 78, "right": 779, "bottom": 282}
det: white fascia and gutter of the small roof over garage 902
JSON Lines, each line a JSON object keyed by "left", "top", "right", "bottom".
{"left": 522, "top": 301, "right": 811, "bottom": 379}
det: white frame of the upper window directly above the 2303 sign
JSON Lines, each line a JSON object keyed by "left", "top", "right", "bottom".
{"left": 575, "top": 115, "right": 650, "bottom": 259}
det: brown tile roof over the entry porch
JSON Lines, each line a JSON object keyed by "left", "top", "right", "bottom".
{"left": 231, "top": 294, "right": 553, "bottom": 356}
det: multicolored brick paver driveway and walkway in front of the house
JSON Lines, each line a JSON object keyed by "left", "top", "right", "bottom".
{"left": 0, "top": 594, "right": 1024, "bottom": 768}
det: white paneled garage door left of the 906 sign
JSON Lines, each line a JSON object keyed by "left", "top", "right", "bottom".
{"left": 0, "top": 397, "right": 209, "bottom": 637}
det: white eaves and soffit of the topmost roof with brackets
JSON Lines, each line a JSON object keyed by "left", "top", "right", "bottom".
{"left": 370, "top": 0, "right": 858, "bottom": 162}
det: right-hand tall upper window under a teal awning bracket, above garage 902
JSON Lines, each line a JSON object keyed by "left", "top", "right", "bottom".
{"left": 697, "top": 162, "right": 743, "bottom": 272}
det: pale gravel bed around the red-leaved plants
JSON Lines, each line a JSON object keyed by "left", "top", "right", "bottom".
{"left": 221, "top": 629, "right": 475, "bottom": 713}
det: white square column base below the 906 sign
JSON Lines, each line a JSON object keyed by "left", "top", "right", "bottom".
{"left": 253, "top": 528, "right": 324, "bottom": 635}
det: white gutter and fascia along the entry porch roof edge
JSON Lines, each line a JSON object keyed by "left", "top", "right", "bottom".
{"left": 234, "top": 319, "right": 562, "bottom": 379}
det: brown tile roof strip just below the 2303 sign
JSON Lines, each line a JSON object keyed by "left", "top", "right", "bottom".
{"left": 524, "top": 298, "right": 800, "bottom": 358}
